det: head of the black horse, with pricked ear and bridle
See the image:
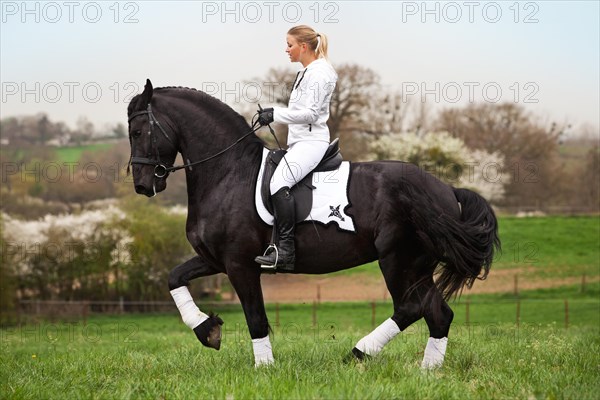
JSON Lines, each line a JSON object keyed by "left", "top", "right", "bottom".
{"left": 127, "top": 79, "right": 177, "bottom": 197}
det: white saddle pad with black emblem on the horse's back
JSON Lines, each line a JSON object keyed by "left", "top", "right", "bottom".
{"left": 254, "top": 149, "right": 356, "bottom": 232}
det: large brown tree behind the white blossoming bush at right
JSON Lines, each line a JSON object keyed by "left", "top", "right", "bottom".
{"left": 434, "top": 103, "right": 565, "bottom": 207}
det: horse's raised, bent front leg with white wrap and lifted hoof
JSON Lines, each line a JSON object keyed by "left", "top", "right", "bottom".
{"left": 169, "top": 256, "right": 223, "bottom": 350}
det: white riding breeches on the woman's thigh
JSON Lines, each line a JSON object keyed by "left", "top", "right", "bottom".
{"left": 271, "top": 140, "right": 329, "bottom": 194}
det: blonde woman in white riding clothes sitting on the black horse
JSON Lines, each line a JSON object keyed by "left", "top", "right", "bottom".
{"left": 255, "top": 25, "right": 338, "bottom": 271}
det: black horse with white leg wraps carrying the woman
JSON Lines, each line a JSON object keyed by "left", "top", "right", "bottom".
{"left": 128, "top": 80, "right": 500, "bottom": 367}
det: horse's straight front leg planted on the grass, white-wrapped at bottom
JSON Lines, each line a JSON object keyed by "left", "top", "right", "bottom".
{"left": 227, "top": 264, "right": 275, "bottom": 367}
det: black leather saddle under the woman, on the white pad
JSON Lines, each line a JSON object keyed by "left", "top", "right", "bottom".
{"left": 260, "top": 138, "right": 343, "bottom": 222}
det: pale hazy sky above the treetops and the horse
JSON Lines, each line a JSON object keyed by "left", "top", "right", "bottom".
{"left": 0, "top": 1, "right": 600, "bottom": 135}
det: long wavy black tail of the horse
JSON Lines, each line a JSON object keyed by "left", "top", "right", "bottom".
{"left": 411, "top": 188, "right": 500, "bottom": 302}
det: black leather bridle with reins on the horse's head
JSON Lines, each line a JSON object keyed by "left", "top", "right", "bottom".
{"left": 127, "top": 103, "right": 261, "bottom": 178}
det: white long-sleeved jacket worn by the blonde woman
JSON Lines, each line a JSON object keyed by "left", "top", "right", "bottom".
{"left": 273, "top": 58, "right": 338, "bottom": 146}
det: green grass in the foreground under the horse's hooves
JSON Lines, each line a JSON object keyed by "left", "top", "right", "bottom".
{"left": 0, "top": 283, "right": 600, "bottom": 399}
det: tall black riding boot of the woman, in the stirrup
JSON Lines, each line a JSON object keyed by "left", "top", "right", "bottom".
{"left": 254, "top": 186, "right": 296, "bottom": 271}
